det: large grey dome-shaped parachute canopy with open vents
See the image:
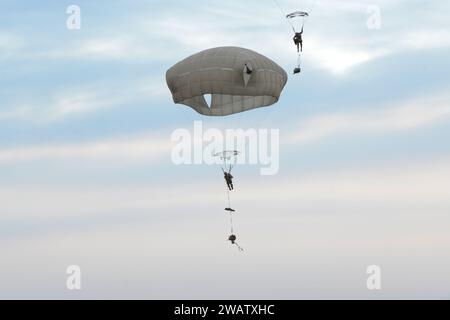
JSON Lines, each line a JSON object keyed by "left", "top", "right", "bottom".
{"left": 166, "top": 47, "right": 287, "bottom": 116}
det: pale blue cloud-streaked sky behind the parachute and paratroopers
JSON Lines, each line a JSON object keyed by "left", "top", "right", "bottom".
{"left": 0, "top": 0, "right": 450, "bottom": 299}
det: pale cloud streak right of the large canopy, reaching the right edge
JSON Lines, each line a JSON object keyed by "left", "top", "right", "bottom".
{"left": 284, "top": 90, "right": 450, "bottom": 144}
